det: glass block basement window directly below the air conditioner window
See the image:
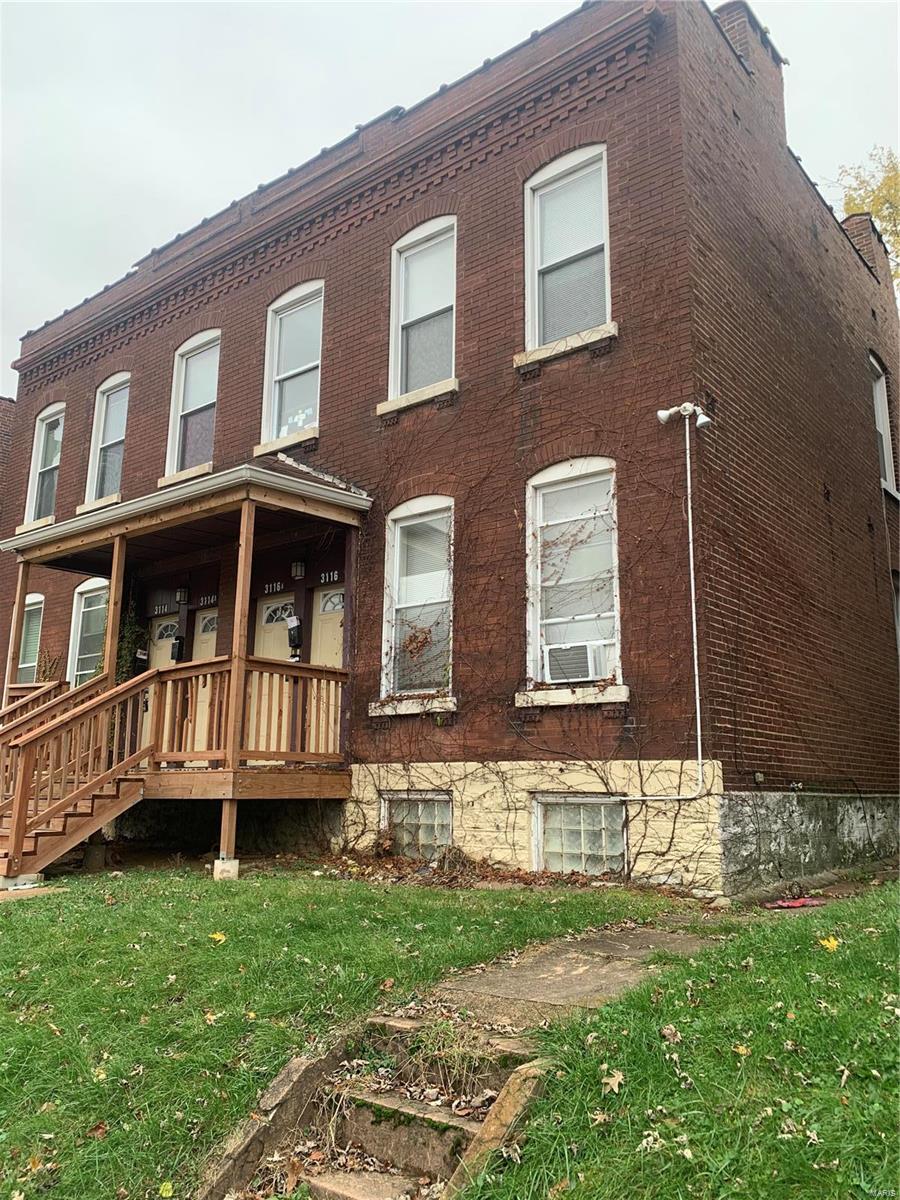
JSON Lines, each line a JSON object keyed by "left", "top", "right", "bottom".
{"left": 538, "top": 796, "right": 625, "bottom": 875}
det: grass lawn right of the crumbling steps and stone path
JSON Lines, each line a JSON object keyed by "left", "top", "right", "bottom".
{"left": 466, "top": 886, "right": 900, "bottom": 1200}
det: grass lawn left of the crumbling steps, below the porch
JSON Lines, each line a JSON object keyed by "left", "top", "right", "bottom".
{"left": 0, "top": 871, "right": 666, "bottom": 1200}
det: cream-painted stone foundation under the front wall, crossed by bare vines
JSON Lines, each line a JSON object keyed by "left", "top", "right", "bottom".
{"left": 344, "top": 761, "right": 722, "bottom": 895}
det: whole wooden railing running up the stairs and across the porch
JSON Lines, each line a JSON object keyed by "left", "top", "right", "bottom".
{"left": 0, "top": 658, "right": 348, "bottom": 865}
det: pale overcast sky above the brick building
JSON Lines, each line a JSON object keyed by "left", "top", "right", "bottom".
{"left": 0, "top": 0, "right": 898, "bottom": 395}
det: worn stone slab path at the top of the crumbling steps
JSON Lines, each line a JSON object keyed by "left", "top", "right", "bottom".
{"left": 432, "top": 928, "right": 708, "bottom": 1028}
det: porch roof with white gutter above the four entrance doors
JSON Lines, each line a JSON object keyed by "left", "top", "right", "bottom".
{"left": 0, "top": 456, "right": 372, "bottom": 575}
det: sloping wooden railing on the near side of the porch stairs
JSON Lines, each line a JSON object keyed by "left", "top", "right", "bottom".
{"left": 0, "top": 668, "right": 158, "bottom": 876}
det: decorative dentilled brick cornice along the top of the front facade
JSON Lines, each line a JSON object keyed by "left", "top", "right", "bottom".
{"left": 19, "top": 6, "right": 659, "bottom": 395}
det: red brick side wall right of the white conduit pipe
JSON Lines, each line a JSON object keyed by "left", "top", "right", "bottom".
{"left": 678, "top": 5, "right": 898, "bottom": 793}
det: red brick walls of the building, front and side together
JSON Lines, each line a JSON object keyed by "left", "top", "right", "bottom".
{"left": 0, "top": 2, "right": 892, "bottom": 786}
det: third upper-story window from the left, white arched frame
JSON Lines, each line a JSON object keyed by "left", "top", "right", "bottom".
{"left": 166, "top": 329, "right": 221, "bottom": 475}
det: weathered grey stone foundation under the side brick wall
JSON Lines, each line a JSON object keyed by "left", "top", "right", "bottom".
{"left": 718, "top": 792, "right": 898, "bottom": 895}
